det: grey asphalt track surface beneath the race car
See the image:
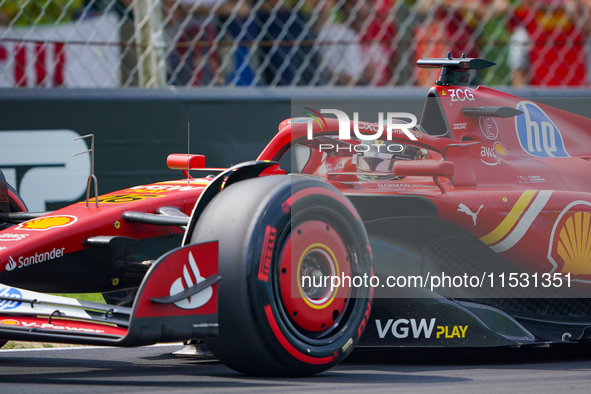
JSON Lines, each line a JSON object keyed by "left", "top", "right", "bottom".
{"left": 0, "top": 345, "right": 591, "bottom": 394}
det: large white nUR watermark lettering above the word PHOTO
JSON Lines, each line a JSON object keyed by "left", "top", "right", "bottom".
{"left": 304, "top": 107, "right": 417, "bottom": 141}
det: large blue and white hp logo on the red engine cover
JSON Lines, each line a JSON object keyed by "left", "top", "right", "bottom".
{"left": 515, "top": 101, "right": 570, "bottom": 157}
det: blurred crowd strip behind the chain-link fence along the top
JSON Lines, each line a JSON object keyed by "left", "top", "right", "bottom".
{"left": 0, "top": 0, "right": 591, "bottom": 87}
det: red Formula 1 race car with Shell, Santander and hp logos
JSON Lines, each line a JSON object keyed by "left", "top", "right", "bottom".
{"left": 0, "top": 57, "right": 591, "bottom": 376}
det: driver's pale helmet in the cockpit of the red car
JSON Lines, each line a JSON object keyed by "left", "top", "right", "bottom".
{"left": 356, "top": 128, "right": 429, "bottom": 181}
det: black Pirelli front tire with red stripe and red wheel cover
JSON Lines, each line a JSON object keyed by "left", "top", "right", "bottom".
{"left": 192, "top": 175, "right": 372, "bottom": 376}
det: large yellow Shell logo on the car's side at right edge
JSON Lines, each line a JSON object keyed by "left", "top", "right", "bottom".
{"left": 552, "top": 211, "right": 591, "bottom": 275}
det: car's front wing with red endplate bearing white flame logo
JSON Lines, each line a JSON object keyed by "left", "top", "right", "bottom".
{"left": 0, "top": 242, "right": 221, "bottom": 346}
